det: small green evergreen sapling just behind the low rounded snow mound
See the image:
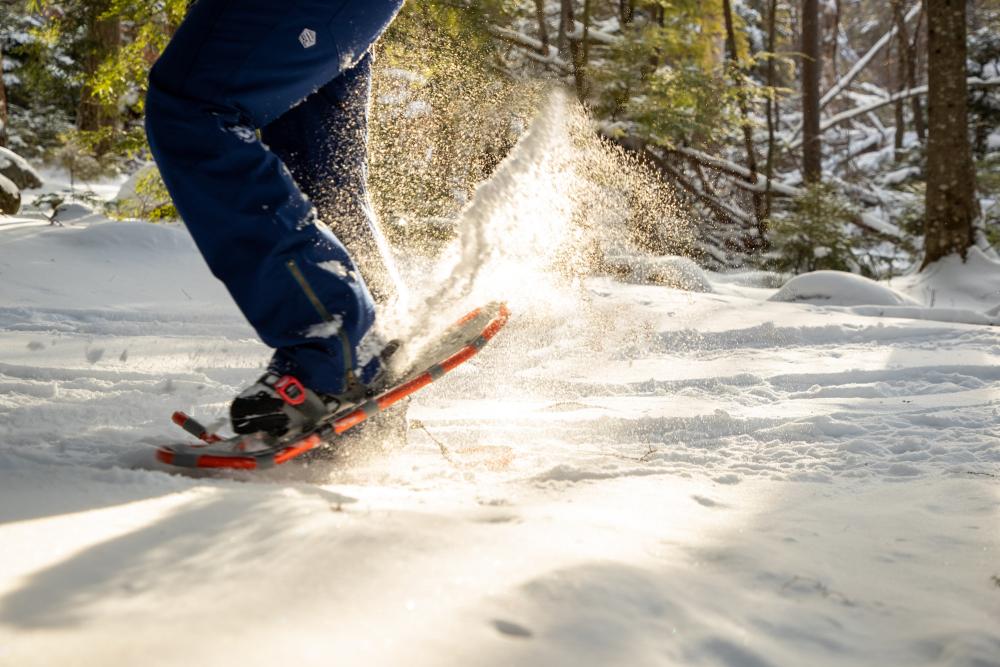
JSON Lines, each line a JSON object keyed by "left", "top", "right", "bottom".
{"left": 769, "top": 185, "right": 858, "bottom": 273}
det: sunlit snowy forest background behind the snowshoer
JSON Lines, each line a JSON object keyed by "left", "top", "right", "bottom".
{"left": 0, "top": 0, "right": 1000, "bottom": 278}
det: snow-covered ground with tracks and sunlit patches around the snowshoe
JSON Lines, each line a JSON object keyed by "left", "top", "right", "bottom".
{"left": 0, "top": 100, "right": 1000, "bottom": 667}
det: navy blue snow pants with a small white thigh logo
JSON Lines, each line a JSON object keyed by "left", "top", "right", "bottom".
{"left": 146, "top": 0, "right": 403, "bottom": 393}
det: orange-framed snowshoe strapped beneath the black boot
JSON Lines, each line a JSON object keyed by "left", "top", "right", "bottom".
{"left": 156, "top": 303, "right": 510, "bottom": 470}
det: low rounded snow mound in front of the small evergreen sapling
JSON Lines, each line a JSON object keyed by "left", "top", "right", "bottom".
{"left": 770, "top": 271, "right": 920, "bottom": 306}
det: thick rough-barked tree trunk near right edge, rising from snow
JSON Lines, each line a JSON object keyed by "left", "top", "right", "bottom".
{"left": 921, "top": 0, "right": 976, "bottom": 268}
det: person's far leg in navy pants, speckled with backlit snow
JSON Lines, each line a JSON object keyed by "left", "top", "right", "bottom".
{"left": 261, "top": 53, "right": 400, "bottom": 304}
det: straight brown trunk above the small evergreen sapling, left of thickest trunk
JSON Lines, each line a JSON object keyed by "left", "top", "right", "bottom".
{"left": 802, "top": 0, "right": 823, "bottom": 184}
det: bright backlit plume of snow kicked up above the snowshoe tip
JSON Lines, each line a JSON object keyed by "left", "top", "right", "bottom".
{"left": 386, "top": 90, "right": 690, "bottom": 370}
